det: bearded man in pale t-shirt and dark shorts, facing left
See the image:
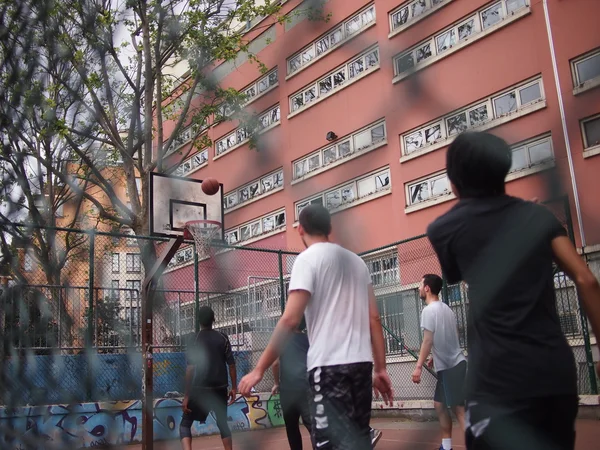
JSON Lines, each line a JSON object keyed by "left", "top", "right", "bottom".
{"left": 412, "top": 274, "right": 467, "bottom": 450}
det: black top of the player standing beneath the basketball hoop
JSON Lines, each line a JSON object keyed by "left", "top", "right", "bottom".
{"left": 186, "top": 330, "right": 235, "bottom": 388}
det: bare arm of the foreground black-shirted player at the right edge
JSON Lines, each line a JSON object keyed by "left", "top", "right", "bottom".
{"left": 552, "top": 236, "right": 600, "bottom": 339}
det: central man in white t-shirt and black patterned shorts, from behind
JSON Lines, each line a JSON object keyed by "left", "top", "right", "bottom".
{"left": 240, "top": 204, "right": 393, "bottom": 450}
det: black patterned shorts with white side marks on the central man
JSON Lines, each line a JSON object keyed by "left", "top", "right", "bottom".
{"left": 309, "top": 363, "right": 373, "bottom": 450}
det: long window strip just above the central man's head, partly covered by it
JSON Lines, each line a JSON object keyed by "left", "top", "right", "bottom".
{"left": 294, "top": 166, "right": 392, "bottom": 221}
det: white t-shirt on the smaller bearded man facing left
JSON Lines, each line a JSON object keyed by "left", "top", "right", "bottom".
{"left": 421, "top": 300, "right": 466, "bottom": 372}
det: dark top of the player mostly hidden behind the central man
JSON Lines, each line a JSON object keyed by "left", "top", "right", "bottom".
{"left": 279, "top": 333, "right": 309, "bottom": 390}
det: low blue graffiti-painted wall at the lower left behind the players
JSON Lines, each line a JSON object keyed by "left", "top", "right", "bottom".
{"left": 0, "top": 394, "right": 283, "bottom": 450}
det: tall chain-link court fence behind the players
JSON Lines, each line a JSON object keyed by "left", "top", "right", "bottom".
{"left": 0, "top": 210, "right": 597, "bottom": 407}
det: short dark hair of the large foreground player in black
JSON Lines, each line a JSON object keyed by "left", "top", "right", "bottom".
{"left": 446, "top": 132, "right": 512, "bottom": 198}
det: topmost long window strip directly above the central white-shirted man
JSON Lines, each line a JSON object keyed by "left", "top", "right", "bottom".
{"left": 285, "top": 2, "right": 377, "bottom": 76}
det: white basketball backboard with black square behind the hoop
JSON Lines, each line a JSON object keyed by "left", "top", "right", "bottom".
{"left": 149, "top": 172, "right": 224, "bottom": 240}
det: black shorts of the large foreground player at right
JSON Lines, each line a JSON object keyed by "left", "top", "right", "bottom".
{"left": 465, "top": 395, "right": 579, "bottom": 450}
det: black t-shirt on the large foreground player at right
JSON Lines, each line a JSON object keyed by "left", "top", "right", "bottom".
{"left": 427, "top": 195, "right": 577, "bottom": 401}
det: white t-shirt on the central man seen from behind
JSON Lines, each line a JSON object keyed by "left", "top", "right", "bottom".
{"left": 289, "top": 242, "right": 373, "bottom": 371}
